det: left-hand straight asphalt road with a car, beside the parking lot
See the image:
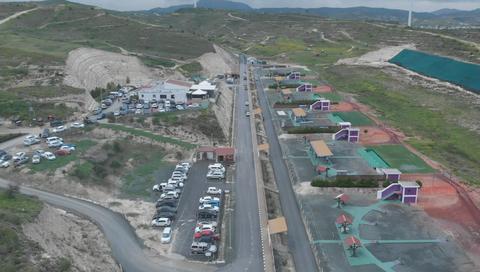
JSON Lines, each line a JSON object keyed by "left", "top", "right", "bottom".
{"left": 221, "top": 56, "right": 264, "bottom": 272}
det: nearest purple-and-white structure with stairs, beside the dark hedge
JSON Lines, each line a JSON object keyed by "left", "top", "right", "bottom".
{"left": 377, "top": 181, "right": 420, "bottom": 204}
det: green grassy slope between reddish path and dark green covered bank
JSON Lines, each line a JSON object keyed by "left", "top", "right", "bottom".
{"left": 325, "top": 66, "right": 480, "bottom": 184}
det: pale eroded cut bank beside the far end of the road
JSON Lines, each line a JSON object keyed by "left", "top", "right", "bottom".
{"left": 198, "top": 45, "right": 238, "bottom": 77}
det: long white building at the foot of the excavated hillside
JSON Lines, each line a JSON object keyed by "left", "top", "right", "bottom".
{"left": 138, "top": 79, "right": 192, "bottom": 104}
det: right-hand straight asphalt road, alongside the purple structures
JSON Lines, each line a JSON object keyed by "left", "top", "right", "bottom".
{"left": 254, "top": 65, "right": 318, "bottom": 271}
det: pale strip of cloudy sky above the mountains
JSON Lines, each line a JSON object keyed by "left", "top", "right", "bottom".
{"left": 0, "top": 0, "right": 480, "bottom": 11}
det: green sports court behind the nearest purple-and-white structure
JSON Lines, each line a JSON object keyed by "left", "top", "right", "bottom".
{"left": 367, "top": 144, "right": 434, "bottom": 173}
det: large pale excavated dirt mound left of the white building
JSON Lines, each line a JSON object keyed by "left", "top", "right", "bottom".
{"left": 64, "top": 48, "right": 154, "bottom": 90}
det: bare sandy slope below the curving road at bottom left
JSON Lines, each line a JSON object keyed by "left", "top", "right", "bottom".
{"left": 23, "top": 205, "right": 120, "bottom": 271}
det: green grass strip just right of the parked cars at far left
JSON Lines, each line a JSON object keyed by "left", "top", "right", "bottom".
{"left": 28, "top": 140, "right": 96, "bottom": 172}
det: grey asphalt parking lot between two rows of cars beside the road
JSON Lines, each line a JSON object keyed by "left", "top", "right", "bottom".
{"left": 152, "top": 161, "right": 230, "bottom": 261}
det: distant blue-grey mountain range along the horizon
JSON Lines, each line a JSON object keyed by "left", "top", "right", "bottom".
{"left": 145, "top": 0, "right": 480, "bottom": 25}
